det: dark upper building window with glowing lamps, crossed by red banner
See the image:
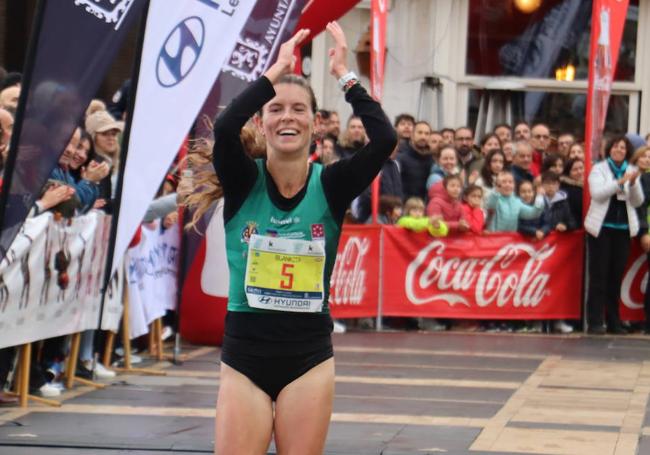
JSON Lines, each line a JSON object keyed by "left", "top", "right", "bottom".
{"left": 466, "top": 0, "right": 639, "bottom": 81}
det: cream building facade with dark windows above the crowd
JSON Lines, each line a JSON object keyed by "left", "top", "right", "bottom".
{"left": 310, "top": 0, "right": 650, "bottom": 138}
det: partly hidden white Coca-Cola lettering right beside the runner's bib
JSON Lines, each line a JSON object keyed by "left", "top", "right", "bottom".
{"left": 330, "top": 237, "right": 370, "bottom": 305}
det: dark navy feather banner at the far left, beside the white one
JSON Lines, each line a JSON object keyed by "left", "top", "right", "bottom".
{"left": 0, "top": 0, "right": 146, "bottom": 259}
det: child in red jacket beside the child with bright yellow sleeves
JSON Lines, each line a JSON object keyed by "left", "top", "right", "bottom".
{"left": 427, "top": 175, "right": 469, "bottom": 232}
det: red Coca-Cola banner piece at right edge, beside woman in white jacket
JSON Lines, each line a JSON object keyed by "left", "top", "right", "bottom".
{"left": 620, "top": 240, "right": 648, "bottom": 321}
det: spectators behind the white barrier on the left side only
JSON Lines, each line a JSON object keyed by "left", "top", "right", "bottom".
{"left": 0, "top": 69, "right": 184, "bottom": 405}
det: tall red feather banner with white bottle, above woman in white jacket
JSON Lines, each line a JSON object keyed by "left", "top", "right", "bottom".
{"left": 584, "top": 0, "right": 629, "bottom": 183}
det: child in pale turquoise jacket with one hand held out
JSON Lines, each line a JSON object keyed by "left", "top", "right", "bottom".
{"left": 486, "top": 171, "right": 544, "bottom": 232}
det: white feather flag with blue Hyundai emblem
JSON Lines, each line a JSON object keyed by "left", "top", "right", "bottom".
{"left": 111, "top": 0, "right": 255, "bottom": 272}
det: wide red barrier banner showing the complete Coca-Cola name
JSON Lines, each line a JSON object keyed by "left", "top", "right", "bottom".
{"left": 380, "top": 227, "right": 584, "bottom": 319}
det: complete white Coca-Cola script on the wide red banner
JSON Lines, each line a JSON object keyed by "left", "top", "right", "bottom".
{"left": 404, "top": 240, "right": 556, "bottom": 308}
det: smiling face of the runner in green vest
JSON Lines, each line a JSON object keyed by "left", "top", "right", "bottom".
{"left": 261, "top": 84, "right": 314, "bottom": 154}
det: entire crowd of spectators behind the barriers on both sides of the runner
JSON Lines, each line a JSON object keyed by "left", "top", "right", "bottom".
{"left": 0, "top": 62, "right": 650, "bottom": 404}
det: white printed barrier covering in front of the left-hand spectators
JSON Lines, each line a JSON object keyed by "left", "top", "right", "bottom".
{"left": 0, "top": 212, "right": 123, "bottom": 348}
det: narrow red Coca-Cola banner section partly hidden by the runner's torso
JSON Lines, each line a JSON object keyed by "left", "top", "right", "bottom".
{"left": 330, "top": 225, "right": 382, "bottom": 318}
